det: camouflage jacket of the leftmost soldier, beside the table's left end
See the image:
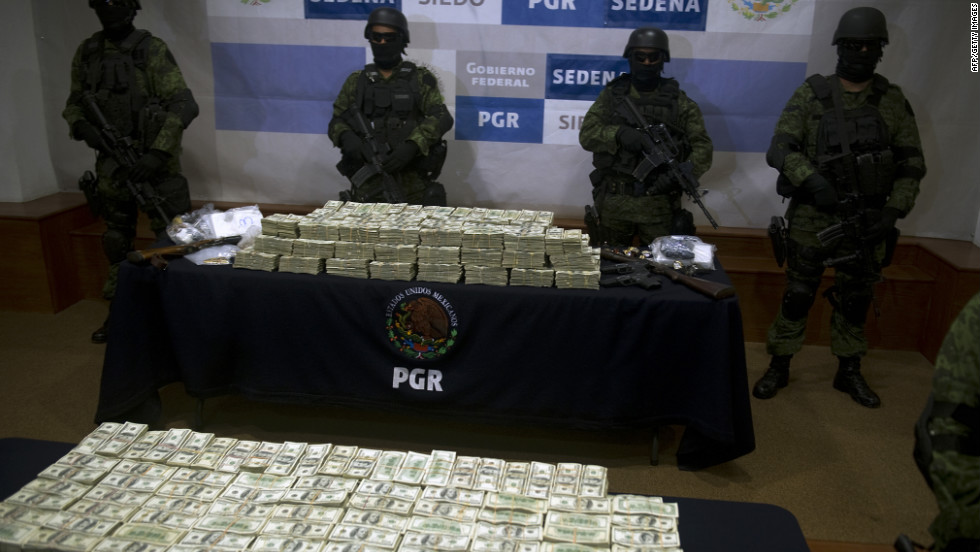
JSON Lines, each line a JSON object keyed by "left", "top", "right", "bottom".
{"left": 62, "top": 30, "right": 198, "bottom": 157}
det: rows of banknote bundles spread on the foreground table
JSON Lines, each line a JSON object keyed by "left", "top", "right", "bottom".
{"left": 0, "top": 423, "right": 681, "bottom": 552}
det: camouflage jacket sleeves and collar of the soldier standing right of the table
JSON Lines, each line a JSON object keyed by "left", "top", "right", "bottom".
{"left": 768, "top": 76, "right": 926, "bottom": 215}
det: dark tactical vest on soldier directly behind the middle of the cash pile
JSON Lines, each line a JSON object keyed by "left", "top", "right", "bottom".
{"left": 356, "top": 61, "right": 422, "bottom": 147}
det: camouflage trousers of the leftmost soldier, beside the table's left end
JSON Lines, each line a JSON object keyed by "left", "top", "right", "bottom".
{"left": 95, "top": 155, "right": 191, "bottom": 300}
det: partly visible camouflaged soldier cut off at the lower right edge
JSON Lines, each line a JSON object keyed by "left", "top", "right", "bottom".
{"left": 915, "top": 293, "right": 980, "bottom": 552}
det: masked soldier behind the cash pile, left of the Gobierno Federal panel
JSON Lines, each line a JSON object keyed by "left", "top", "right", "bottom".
{"left": 327, "top": 8, "right": 453, "bottom": 205}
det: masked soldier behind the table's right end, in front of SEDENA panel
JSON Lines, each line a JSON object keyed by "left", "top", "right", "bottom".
{"left": 579, "top": 27, "right": 714, "bottom": 246}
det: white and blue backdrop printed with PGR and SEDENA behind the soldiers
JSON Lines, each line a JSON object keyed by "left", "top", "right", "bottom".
{"left": 15, "top": 0, "right": 980, "bottom": 241}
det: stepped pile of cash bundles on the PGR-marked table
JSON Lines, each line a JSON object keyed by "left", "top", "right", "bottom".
{"left": 234, "top": 201, "right": 600, "bottom": 289}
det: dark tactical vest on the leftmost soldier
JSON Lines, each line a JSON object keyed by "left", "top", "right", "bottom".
{"left": 82, "top": 29, "right": 150, "bottom": 138}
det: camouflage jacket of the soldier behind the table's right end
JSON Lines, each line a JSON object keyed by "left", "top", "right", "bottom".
{"left": 578, "top": 75, "right": 714, "bottom": 178}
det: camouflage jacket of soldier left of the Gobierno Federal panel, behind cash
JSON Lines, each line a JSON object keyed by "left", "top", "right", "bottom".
{"left": 327, "top": 61, "right": 453, "bottom": 156}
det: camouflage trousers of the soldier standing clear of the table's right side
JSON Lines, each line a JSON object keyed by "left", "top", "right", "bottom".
{"left": 766, "top": 204, "right": 885, "bottom": 357}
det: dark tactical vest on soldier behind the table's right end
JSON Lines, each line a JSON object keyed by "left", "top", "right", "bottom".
{"left": 592, "top": 73, "right": 691, "bottom": 183}
